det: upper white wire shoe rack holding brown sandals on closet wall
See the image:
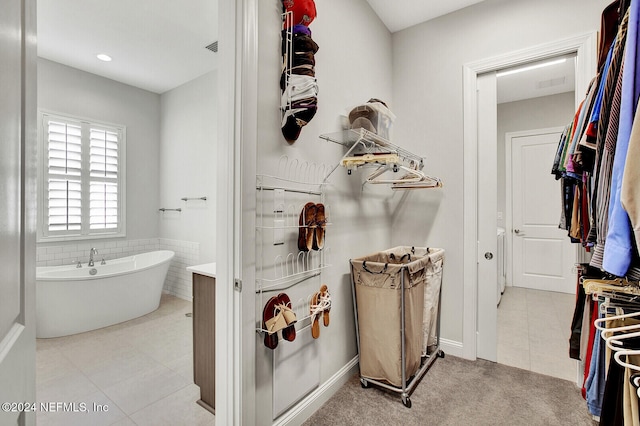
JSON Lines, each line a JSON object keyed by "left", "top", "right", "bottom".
{"left": 256, "top": 156, "right": 331, "bottom": 334}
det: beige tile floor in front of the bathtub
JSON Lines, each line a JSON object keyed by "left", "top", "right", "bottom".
{"left": 36, "top": 294, "right": 215, "bottom": 426}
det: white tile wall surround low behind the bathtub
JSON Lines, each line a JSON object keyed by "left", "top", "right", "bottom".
{"left": 36, "top": 238, "right": 200, "bottom": 301}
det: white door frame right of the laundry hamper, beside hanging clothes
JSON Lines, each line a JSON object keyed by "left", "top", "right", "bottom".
{"left": 462, "top": 31, "right": 597, "bottom": 360}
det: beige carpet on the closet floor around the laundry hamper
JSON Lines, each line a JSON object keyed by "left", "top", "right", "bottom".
{"left": 304, "top": 355, "right": 597, "bottom": 426}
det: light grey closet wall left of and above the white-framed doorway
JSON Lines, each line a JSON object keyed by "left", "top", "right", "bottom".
{"left": 391, "top": 0, "right": 610, "bottom": 350}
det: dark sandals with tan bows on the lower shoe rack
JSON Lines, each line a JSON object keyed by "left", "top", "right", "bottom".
{"left": 262, "top": 293, "right": 297, "bottom": 349}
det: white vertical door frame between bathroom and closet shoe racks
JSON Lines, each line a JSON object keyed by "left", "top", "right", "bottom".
{"left": 215, "top": 0, "right": 258, "bottom": 425}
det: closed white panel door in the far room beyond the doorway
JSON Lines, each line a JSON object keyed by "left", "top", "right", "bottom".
{"left": 507, "top": 129, "right": 576, "bottom": 293}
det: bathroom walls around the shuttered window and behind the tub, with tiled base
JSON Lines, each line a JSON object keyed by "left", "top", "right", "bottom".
{"left": 36, "top": 58, "right": 211, "bottom": 300}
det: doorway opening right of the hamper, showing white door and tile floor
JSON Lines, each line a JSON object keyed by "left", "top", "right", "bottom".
{"left": 496, "top": 55, "right": 577, "bottom": 380}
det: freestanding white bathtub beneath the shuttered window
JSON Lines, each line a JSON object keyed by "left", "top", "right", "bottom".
{"left": 36, "top": 250, "right": 175, "bottom": 338}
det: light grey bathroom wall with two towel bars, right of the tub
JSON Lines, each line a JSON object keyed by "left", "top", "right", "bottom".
{"left": 158, "top": 71, "right": 218, "bottom": 263}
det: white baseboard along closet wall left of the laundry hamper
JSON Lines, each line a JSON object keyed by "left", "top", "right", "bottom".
{"left": 274, "top": 355, "right": 358, "bottom": 426}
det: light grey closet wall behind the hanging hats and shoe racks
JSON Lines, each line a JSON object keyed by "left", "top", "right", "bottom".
{"left": 252, "top": 0, "right": 396, "bottom": 425}
